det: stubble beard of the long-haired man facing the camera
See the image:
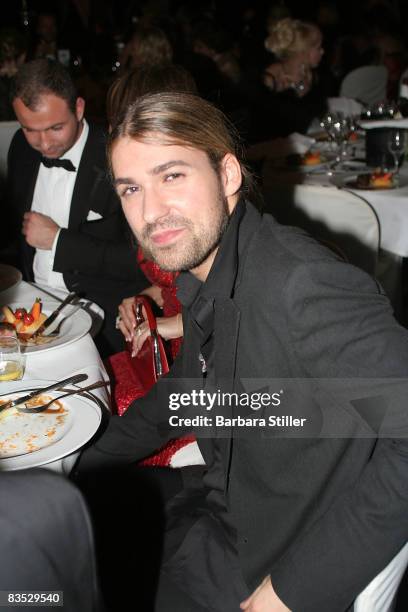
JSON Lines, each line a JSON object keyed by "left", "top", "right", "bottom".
{"left": 136, "top": 187, "right": 229, "bottom": 272}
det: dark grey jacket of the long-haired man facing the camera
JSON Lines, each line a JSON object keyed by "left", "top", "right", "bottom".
{"left": 79, "top": 203, "right": 408, "bottom": 612}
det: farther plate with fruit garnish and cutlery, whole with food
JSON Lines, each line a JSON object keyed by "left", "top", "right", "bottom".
{"left": 0, "top": 298, "right": 92, "bottom": 353}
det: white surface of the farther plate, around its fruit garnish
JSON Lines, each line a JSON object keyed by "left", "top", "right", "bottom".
{"left": 4, "top": 302, "right": 92, "bottom": 354}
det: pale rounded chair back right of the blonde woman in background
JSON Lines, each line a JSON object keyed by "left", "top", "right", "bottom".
{"left": 340, "top": 66, "right": 388, "bottom": 106}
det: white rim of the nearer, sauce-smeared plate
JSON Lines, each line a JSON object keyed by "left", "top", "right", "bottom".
{"left": 0, "top": 380, "right": 102, "bottom": 471}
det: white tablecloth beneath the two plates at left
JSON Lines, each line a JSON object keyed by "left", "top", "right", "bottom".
{"left": 0, "top": 281, "right": 109, "bottom": 473}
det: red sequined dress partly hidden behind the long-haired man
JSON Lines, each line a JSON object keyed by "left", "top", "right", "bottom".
{"left": 108, "top": 249, "right": 195, "bottom": 466}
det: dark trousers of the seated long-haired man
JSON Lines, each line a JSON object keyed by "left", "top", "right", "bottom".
{"left": 75, "top": 466, "right": 249, "bottom": 612}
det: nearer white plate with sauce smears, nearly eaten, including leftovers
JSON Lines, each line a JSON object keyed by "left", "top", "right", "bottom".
{"left": 0, "top": 380, "right": 102, "bottom": 471}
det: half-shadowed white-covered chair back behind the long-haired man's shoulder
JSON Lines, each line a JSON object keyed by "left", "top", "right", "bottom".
{"left": 268, "top": 185, "right": 380, "bottom": 275}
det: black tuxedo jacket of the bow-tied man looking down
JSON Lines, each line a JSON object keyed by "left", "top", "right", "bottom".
{"left": 8, "top": 125, "right": 148, "bottom": 352}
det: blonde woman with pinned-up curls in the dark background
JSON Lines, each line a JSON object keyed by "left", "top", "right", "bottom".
{"left": 264, "top": 17, "right": 324, "bottom": 97}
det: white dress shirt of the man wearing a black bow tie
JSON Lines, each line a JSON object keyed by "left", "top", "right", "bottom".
{"left": 31, "top": 119, "right": 89, "bottom": 291}
